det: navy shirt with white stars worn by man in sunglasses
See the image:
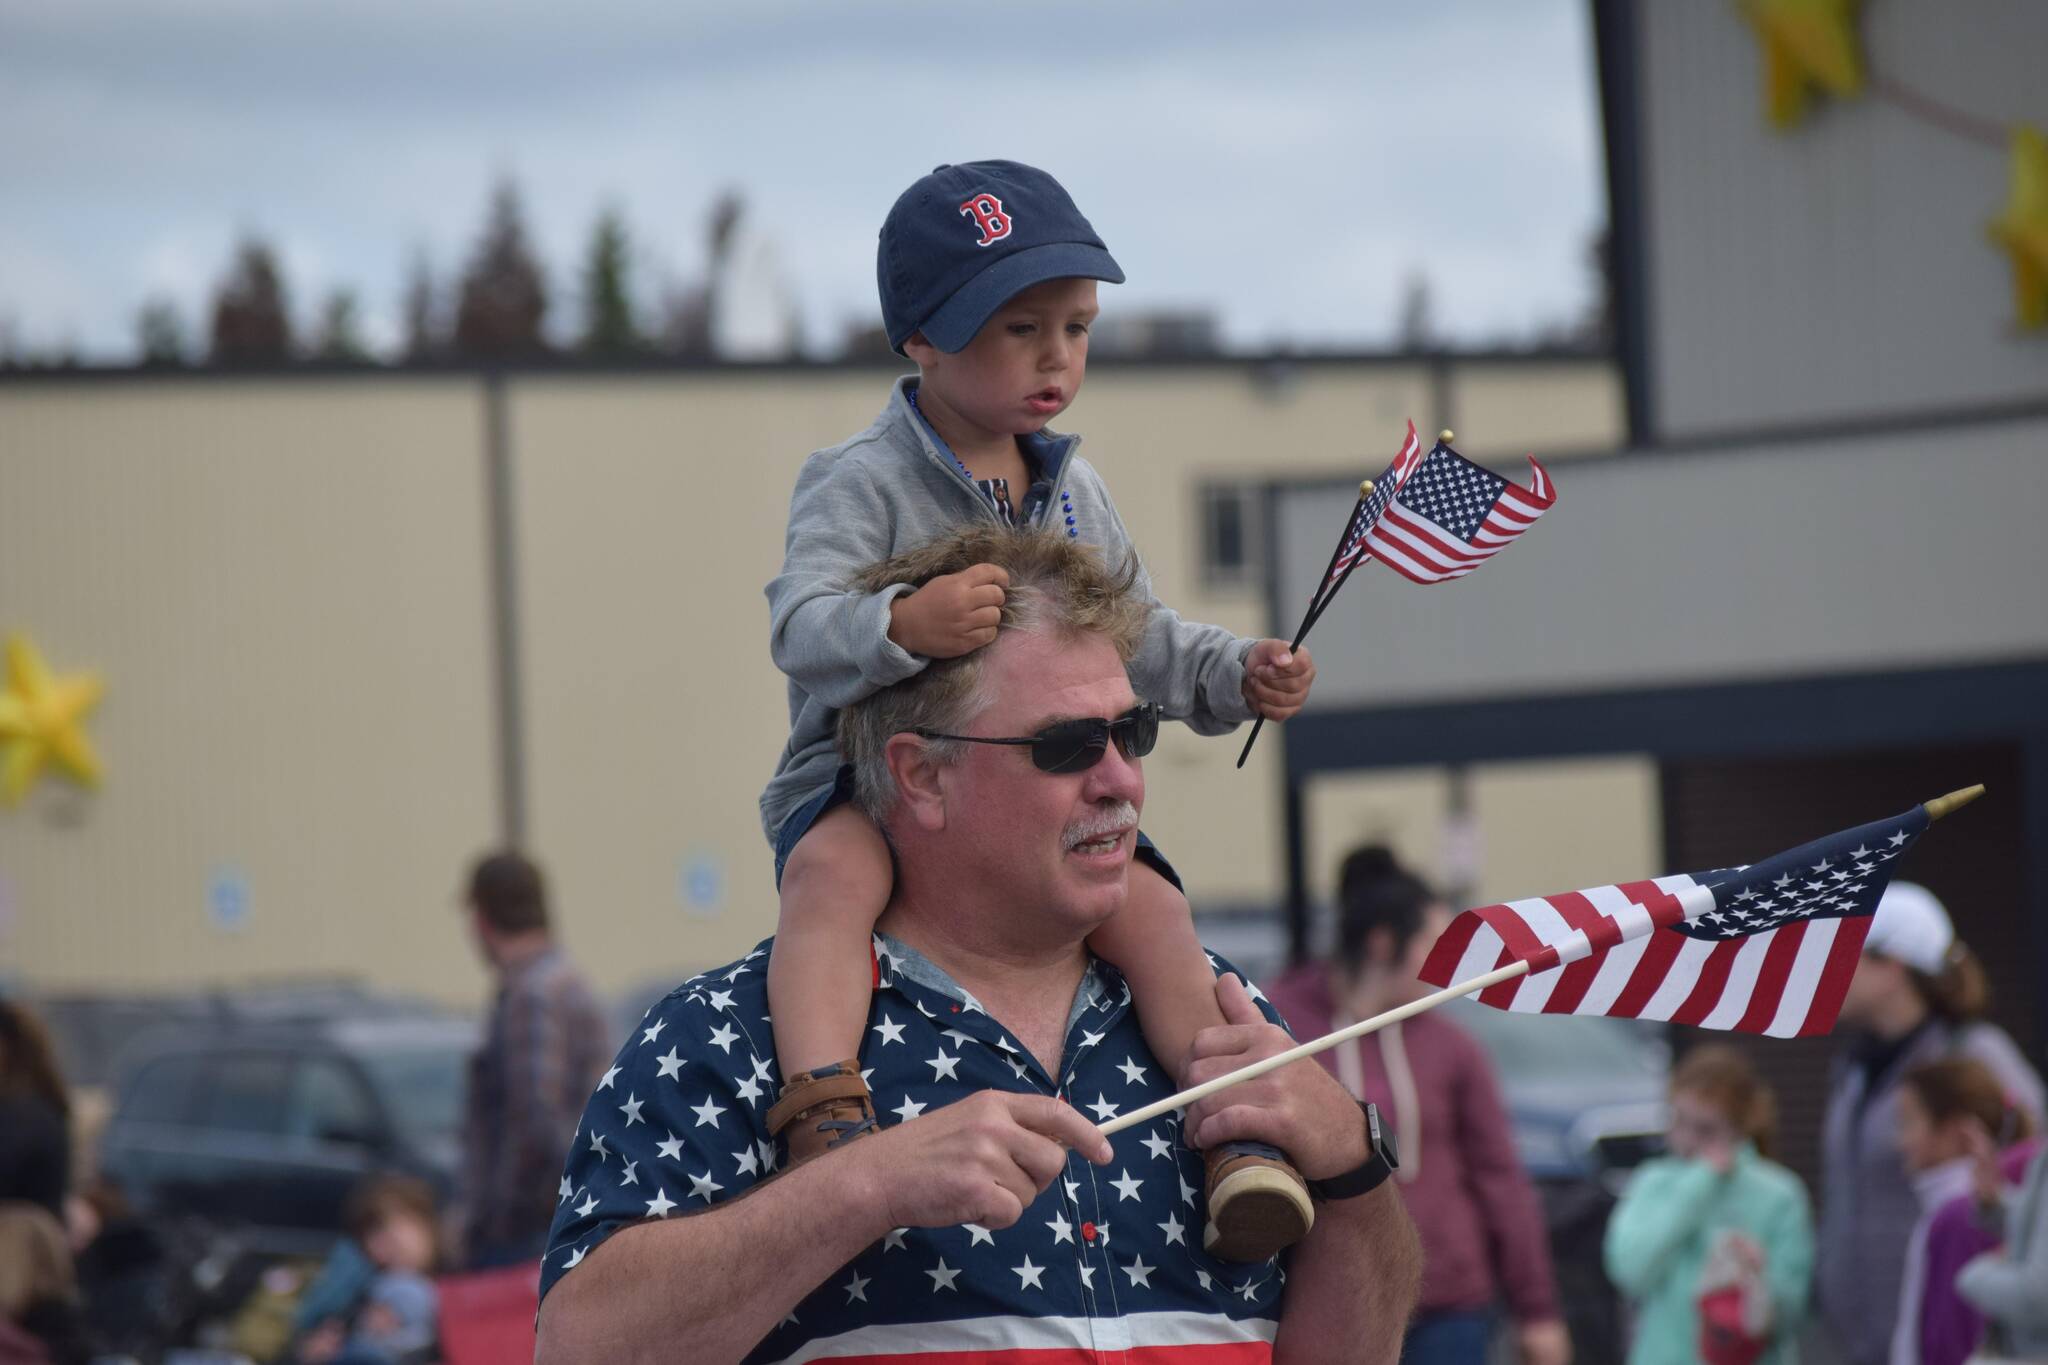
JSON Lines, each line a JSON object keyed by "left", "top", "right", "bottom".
{"left": 541, "top": 937, "right": 1286, "bottom": 1365}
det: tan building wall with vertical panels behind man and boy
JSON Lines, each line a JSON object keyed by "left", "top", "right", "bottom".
{"left": 0, "top": 362, "right": 1640, "bottom": 1001}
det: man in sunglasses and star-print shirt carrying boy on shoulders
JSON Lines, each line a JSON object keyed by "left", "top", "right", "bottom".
{"left": 537, "top": 526, "right": 1419, "bottom": 1365}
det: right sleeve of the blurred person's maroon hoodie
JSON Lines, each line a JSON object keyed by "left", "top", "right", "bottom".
{"left": 1458, "top": 1044, "right": 1559, "bottom": 1322}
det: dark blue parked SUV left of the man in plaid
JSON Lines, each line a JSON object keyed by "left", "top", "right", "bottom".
{"left": 100, "top": 1011, "right": 477, "bottom": 1259}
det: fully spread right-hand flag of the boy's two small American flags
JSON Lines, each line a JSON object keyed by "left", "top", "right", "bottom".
{"left": 1364, "top": 442, "right": 1556, "bottom": 583}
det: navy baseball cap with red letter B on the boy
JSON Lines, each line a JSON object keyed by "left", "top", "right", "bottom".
{"left": 874, "top": 162, "right": 1124, "bottom": 354}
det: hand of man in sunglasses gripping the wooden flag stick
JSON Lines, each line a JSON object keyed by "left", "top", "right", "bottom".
{"left": 840, "top": 1091, "right": 1112, "bottom": 1228}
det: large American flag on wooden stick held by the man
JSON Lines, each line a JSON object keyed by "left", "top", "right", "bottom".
{"left": 1421, "top": 806, "right": 1927, "bottom": 1038}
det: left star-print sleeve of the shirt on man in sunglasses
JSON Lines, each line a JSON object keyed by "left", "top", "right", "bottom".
{"left": 541, "top": 988, "right": 774, "bottom": 1297}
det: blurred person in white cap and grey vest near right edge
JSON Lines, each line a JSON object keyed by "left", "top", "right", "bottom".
{"left": 1817, "top": 882, "right": 2042, "bottom": 1365}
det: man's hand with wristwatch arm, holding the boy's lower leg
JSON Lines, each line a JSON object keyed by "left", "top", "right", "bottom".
{"left": 1186, "top": 974, "right": 1368, "bottom": 1181}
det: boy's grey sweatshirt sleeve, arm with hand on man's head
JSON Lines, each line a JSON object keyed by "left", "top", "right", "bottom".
{"left": 768, "top": 452, "right": 928, "bottom": 710}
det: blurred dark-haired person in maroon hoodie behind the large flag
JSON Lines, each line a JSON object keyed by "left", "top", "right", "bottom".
{"left": 1270, "top": 845, "right": 1571, "bottom": 1365}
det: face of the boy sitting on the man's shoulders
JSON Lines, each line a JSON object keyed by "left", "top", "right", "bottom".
{"left": 903, "top": 278, "right": 1098, "bottom": 436}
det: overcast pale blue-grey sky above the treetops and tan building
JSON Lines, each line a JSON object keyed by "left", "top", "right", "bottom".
{"left": 0, "top": 0, "right": 1606, "bottom": 360}
